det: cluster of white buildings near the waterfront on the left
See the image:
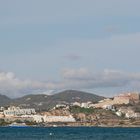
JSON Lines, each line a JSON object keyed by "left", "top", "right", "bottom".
{"left": 0, "top": 106, "right": 76, "bottom": 123}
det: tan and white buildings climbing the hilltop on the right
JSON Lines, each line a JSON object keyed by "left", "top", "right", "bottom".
{"left": 68, "top": 93, "right": 140, "bottom": 118}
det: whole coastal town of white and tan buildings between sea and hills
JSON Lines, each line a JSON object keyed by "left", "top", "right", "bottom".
{"left": 0, "top": 92, "right": 140, "bottom": 127}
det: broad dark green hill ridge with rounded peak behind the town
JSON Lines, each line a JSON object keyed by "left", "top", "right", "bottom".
{"left": 0, "top": 90, "right": 104, "bottom": 110}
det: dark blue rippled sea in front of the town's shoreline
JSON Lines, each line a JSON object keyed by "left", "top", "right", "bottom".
{"left": 0, "top": 127, "right": 140, "bottom": 140}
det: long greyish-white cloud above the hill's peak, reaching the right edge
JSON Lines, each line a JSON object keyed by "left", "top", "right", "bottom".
{"left": 58, "top": 68, "right": 140, "bottom": 90}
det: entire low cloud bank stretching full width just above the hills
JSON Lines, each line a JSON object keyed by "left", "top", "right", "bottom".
{"left": 0, "top": 68, "right": 140, "bottom": 97}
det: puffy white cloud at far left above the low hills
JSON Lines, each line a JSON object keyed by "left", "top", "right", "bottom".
{"left": 0, "top": 72, "right": 47, "bottom": 96}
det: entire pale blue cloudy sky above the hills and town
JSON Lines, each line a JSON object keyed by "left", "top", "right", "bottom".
{"left": 0, "top": 0, "right": 140, "bottom": 97}
